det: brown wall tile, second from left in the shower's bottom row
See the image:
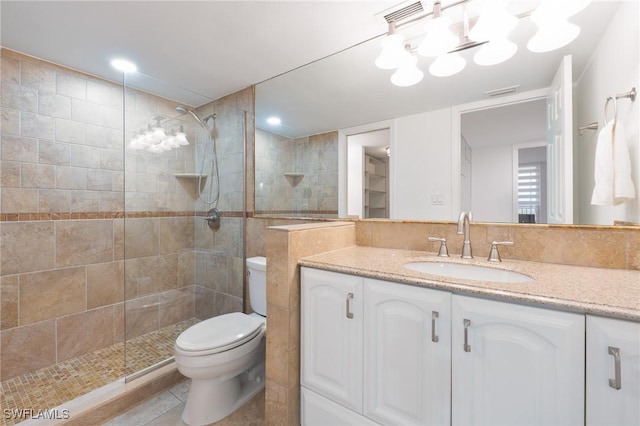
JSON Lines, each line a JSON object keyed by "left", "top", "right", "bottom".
{"left": 56, "top": 306, "right": 116, "bottom": 362}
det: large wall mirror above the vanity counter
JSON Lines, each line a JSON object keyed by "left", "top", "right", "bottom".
{"left": 255, "top": 0, "right": 640, "bottom": 225}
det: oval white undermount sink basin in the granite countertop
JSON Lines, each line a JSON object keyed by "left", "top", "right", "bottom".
{"left": 404, "top": 262, "right": 534, "bottom": 283}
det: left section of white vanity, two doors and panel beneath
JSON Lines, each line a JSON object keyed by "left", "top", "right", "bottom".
{"left": 301, "top": 268, "right": 451, "bottom": 425}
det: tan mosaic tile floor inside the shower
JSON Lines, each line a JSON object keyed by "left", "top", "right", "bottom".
{"left": 0, "top": 318, "right": 199, "bottom": 425}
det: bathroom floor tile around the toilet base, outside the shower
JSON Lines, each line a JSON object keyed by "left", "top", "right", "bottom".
{"left": 105, "top": 380, "right": 265, "bottom": 426}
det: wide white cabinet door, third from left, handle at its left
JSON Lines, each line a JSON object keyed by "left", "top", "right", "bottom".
{"left": 451, "top": 295, "right": 585, "bottom": 425}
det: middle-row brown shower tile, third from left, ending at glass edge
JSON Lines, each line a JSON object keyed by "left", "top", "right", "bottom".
{"left": 87, "top": 261, "right": 124, "bottom": 309}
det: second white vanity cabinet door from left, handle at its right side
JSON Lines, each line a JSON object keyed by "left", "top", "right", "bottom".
{"left": 364, "top": 279, "right": 451, "bottom": 425}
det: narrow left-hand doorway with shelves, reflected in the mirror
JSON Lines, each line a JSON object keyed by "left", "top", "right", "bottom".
{"left": 347, "top": 128, "right": 390, "bottom": 219}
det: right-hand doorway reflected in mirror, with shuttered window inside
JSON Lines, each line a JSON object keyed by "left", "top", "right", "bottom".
{"left": 460, "top": 98, "right": 547, "bottom": 223}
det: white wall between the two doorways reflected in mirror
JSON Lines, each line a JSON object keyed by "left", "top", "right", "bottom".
{"left": 390, "top": 108, "right": 452, "bottom": 220}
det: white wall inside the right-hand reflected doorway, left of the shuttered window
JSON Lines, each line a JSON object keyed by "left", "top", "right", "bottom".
{"left": 471, "top": 145, "right": 514, "bottom": 222}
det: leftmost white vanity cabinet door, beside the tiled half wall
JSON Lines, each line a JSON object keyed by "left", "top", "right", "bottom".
{"left": 300, "top": 268, "right": 363, "bottom": 413}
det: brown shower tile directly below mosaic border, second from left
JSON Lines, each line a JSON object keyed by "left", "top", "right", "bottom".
{"left": 56, "top": 220, "right": 113, "bottom": 268}
